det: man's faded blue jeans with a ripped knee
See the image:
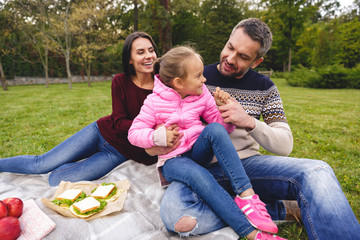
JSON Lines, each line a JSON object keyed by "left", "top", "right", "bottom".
{"left": 160, "top": 155, "right": 360, "bottom": 240}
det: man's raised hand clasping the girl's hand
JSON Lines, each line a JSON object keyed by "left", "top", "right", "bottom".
{"left": 219, "top": 98, "right": 256, "bottom": 131}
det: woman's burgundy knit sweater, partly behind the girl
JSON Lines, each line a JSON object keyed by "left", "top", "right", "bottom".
{"left": 97, "top": 73, "right": 157, "bottom": 165}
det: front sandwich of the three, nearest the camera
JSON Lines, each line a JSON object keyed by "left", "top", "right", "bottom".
{"left": 70, "top": 197, "right": 107, "bottom": 218}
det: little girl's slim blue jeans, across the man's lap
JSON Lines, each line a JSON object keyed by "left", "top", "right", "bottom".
{"left": 161, "top": 123, "right": 253, "bottom": 234}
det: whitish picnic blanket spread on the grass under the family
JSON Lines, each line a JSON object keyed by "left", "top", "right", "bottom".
{"left": 0, "top": 160, "right": 239, "bottom": 240}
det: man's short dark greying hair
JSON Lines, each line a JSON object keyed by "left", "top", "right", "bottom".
{"left": 231, "top": 18, "right": 272, "bottom": 58}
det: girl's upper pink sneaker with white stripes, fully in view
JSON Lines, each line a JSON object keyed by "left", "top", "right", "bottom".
{"left": 235, "top": 194, "right": 278, "bottom": 233}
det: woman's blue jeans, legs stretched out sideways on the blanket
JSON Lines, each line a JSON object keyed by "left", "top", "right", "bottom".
{"left": 0, "top": 122, "right": 126, "bottom": 186}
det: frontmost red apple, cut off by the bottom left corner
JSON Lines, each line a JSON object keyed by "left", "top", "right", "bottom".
{"left": 0, "top": 217, "right": 21, "bottom": 240}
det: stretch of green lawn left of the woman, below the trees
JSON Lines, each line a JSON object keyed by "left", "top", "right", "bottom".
{"left": 0, "top": 82, "right": 112, "bottom": 158}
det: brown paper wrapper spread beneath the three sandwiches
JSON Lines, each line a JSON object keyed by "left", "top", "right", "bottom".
{"left": 41, "top": 179, "right": 130, "bottom": 221}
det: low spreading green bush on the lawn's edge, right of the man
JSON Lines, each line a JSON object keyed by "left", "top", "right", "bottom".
{"left": 286, "top": 65, "right": 360, "bottom": 89}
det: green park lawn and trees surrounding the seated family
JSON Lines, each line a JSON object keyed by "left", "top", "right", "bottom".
{"left": 0, "top": 0, "right": 360, "bottom": 239}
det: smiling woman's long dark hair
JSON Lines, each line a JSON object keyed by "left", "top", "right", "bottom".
{"left": 122, "top": 32, "right": 159, "bottom": 77}
